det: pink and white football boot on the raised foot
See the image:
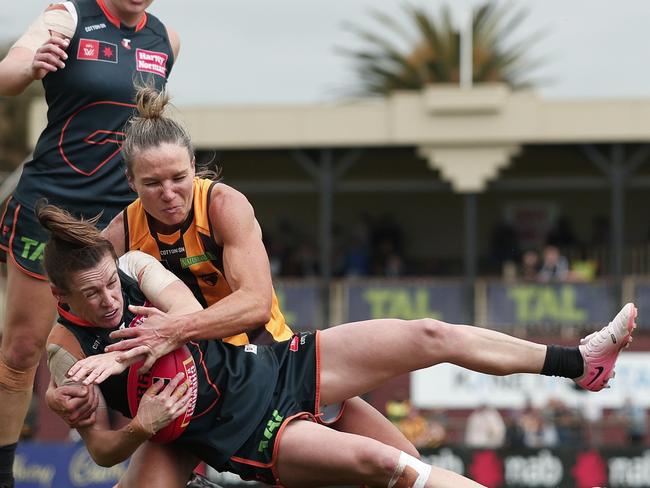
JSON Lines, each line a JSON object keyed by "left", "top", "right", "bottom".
{"left": 574, "top": 303, "right": 637, "bottom": 391}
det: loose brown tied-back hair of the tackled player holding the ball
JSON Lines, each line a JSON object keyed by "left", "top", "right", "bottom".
{"left": 36, "top": 201, "right": 117, "bottom": 292}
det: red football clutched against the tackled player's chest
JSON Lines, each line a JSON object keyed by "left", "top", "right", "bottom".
{"left": 127, "top": 346, "right": 198, "bottom": 444}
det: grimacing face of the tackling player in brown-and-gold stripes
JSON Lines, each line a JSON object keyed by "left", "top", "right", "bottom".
{"left": 129, "top": 144, "right": 194, "bottom": 233}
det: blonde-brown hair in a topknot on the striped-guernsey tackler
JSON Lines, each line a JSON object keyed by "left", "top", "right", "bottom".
{"left": 122, "top": 83, "right": 194, "bottom": 177}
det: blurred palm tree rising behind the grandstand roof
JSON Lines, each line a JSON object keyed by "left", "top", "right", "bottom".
{"left": 341, "top": 2, "right": 540, "bottom": 95}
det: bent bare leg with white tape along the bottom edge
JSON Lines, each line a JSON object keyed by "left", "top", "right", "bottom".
{"left": 275, "top": 420, "right": 481, "bottom": 488}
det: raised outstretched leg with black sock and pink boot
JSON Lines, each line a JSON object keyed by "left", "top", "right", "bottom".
{"left": 320, "top": 304, "right": 636, "bottom": 404}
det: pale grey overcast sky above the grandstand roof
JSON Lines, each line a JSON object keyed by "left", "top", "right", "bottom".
{"left": 0, "top": 0, "right": 650, "bottom": 105}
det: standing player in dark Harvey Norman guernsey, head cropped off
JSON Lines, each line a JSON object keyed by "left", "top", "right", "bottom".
{"left": 0, "top": 0, "right": 180, "bottom": 488}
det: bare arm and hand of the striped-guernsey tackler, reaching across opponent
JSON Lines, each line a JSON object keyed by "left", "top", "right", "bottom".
{"left": 106, "top": 185, "right": 272, "bottom": 370}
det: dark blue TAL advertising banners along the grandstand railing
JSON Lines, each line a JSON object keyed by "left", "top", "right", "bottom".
{"left": 0, "top": 276, "right": 650, "bottom": 336}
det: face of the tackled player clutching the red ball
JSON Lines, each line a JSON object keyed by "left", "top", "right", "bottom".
{"left": 60, "top": 254, "right": 124, "bottom": 328}
